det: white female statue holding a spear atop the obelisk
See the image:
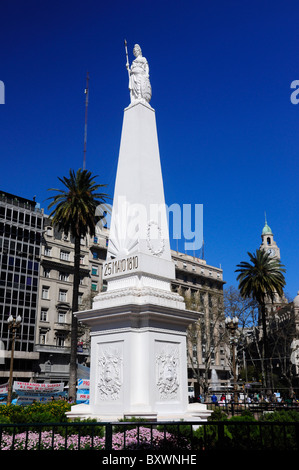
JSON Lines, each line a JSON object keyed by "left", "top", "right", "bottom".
{"left": 125, "top": 41, "right": 152, "bottom": 104}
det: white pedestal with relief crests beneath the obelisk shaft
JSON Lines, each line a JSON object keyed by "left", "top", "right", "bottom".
{"left": 68, "top": 289, "right": 198, "bottom": 421}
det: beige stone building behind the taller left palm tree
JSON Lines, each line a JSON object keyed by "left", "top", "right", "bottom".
{"left": 35, "top": 216, "right": 108, "bottom": 383}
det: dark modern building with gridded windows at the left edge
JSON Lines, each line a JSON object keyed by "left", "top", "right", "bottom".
{"left": 0, "top": 191, "right": 43, "bottom": 383}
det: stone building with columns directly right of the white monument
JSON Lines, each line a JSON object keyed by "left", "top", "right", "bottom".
{"left": 172, "top": 251, "right": 230, "bottom": 396}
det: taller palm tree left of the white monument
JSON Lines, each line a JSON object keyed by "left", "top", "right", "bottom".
{"left": 48, "top": 169, "right": 109, "bottom": 398}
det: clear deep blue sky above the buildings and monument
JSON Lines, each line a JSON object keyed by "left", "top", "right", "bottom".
{"left": 0, "top": 0, "right": 299, "bottom": 297}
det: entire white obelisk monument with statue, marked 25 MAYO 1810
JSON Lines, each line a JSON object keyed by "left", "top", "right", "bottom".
{"left": 70, "top": 45, "right": 202, "bottom": 421}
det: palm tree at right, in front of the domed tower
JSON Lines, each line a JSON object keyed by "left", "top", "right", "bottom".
{"left": 236, "top": 250, "right": 285, "bottom": 392}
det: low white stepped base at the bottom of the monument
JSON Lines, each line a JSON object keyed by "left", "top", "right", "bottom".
{"left": 66, "top": 403, "right": 212, "bottom": 422}
